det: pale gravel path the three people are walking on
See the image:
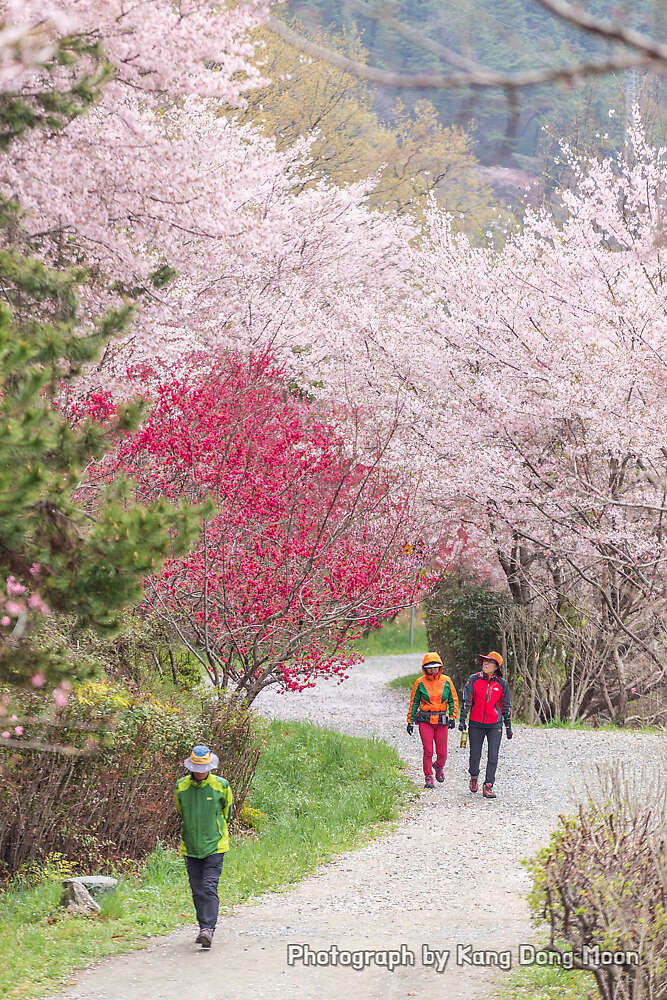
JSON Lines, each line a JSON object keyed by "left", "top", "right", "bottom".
{"left": 45, "top": 654, "right": 664, "bottom": 1000}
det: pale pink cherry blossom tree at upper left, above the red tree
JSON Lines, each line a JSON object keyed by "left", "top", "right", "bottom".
{"left": 0, "top": 0, "right": 415, "bottom": 396}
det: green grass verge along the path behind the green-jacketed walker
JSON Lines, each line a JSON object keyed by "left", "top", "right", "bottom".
{"left": 0, "top": 722, "right": 416, "bottom": 1000}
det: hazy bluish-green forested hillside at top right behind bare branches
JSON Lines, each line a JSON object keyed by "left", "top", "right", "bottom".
{"left": 288, "top": 0, "right": 666, "bottom": 170}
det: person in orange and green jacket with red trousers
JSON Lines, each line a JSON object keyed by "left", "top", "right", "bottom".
{"left": 408, "top": 653, "right": 459, "bottom": 788}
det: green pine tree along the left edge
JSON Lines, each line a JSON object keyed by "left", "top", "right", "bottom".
{"left": 0, "top": 31, "right": 199, "bottom": 686}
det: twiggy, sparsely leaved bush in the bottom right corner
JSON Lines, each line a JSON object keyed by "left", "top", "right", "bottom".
{"left": 530, "top": 761, "right": 667, "bottom": 1000}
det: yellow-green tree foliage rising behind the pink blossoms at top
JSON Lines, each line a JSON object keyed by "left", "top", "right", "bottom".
{"left": 236, "top": 25, "right": 498, "bottom": 233}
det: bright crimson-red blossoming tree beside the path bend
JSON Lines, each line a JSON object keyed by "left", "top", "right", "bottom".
{"left": 92, "top": 356, "right": 428, "bottom": 702}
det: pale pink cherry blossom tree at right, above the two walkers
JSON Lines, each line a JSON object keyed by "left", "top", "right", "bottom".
{"left": 310, "top": 122, "right": 667, "bottom": 719}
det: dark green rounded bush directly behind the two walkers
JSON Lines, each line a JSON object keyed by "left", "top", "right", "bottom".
{"left": 424, "top": 577, "right": 509, "bottom": 690}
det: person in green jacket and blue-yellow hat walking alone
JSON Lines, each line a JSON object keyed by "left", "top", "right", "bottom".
{"left": 175, "top": 746, "right": 234, "bottom": 948}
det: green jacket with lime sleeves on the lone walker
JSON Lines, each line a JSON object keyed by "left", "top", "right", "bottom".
{"left": 174, "top": 772, "right": 234, "bottom": 858}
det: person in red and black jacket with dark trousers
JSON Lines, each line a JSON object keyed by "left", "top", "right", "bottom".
{"left": 459, "top": 651, "right": 512, "bottom": 799}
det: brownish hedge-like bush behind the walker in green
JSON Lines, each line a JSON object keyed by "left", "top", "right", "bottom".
{"left": 0, "top": 681, "right": 259, "bottom": 875}
